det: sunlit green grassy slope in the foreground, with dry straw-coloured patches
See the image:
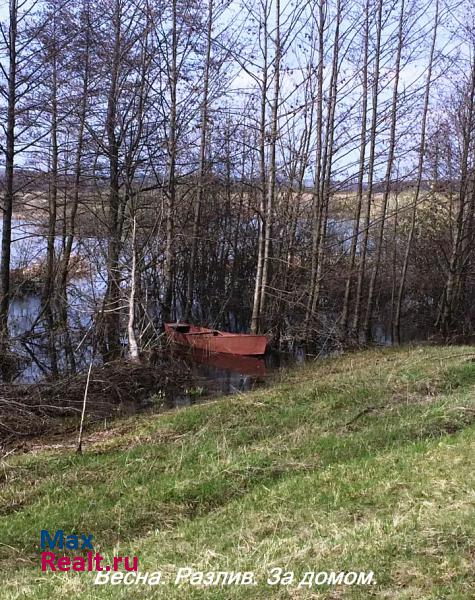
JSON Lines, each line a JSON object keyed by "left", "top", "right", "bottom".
{"left": 0, "top": 347, "right": 475, "bottom": 600}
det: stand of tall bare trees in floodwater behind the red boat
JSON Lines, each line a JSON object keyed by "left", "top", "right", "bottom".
{"left": 0, "top": 0, "right": 475, "bottom": 378}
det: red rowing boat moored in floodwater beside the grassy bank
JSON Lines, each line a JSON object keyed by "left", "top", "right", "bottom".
{"left": 165, "top": 323, "right": 267, "bottom": 356}
